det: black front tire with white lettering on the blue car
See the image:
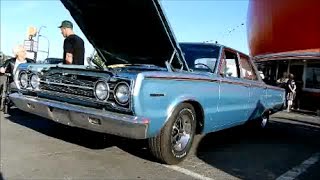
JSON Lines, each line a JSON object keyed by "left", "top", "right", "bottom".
{"left": 149, "top": 103, "right": 196, "bottom": 164}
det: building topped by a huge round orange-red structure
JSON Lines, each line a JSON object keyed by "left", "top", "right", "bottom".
{"left": 247, "top": 0, "right": 320, "bottom": 111}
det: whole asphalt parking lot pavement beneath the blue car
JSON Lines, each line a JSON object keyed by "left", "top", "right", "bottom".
{"left": 0, "top": 110, "right": 320, "bottom": 180}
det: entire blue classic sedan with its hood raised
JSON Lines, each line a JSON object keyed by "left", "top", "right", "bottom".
{"left": 10, "top": 0, "right": 285, "bottom": 164}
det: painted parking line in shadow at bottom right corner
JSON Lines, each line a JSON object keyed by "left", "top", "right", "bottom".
{"left": 276, "top": 153, "right": 320, "bottom": 180}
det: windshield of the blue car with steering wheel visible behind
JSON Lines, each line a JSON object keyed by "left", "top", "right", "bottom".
{"left": 180, "top": 43, "right": 220, "bottom": 72}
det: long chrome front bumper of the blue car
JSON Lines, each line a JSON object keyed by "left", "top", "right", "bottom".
{"left": 9, "top": 93, "right": 149, "bottom": 139}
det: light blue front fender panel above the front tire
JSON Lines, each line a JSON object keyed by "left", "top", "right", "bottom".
{"left": 132, "top": 74, "right": 218, "bottom": 137}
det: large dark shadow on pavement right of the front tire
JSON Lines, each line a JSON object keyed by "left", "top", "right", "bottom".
{"left": 196, "top": 121, "right": 320, "bottom": 180}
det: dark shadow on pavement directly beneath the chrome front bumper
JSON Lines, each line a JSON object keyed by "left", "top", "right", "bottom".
{"left": 7, "top": 109, "right": 156, "bottom": 162}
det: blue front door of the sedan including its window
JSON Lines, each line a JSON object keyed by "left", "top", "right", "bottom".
{"left": 217, "top": 49, "right": 250, "bottom": 126}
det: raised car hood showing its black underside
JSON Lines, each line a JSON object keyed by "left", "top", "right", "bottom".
{"left": 61, "top": 0, "right": 188, "bottom": 69}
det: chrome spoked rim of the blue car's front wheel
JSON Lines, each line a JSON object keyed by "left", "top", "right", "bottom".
{"left": 171, "top": 109, "right": 194, "bottom": 152}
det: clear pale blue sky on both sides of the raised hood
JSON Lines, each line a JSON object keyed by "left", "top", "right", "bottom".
{"left": 0, "top": 0, "right": 249, "bottom": 59}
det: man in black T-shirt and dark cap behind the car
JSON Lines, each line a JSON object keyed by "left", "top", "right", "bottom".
{"left": 59, "top": 21, "right": 85, "bottom": 65}
